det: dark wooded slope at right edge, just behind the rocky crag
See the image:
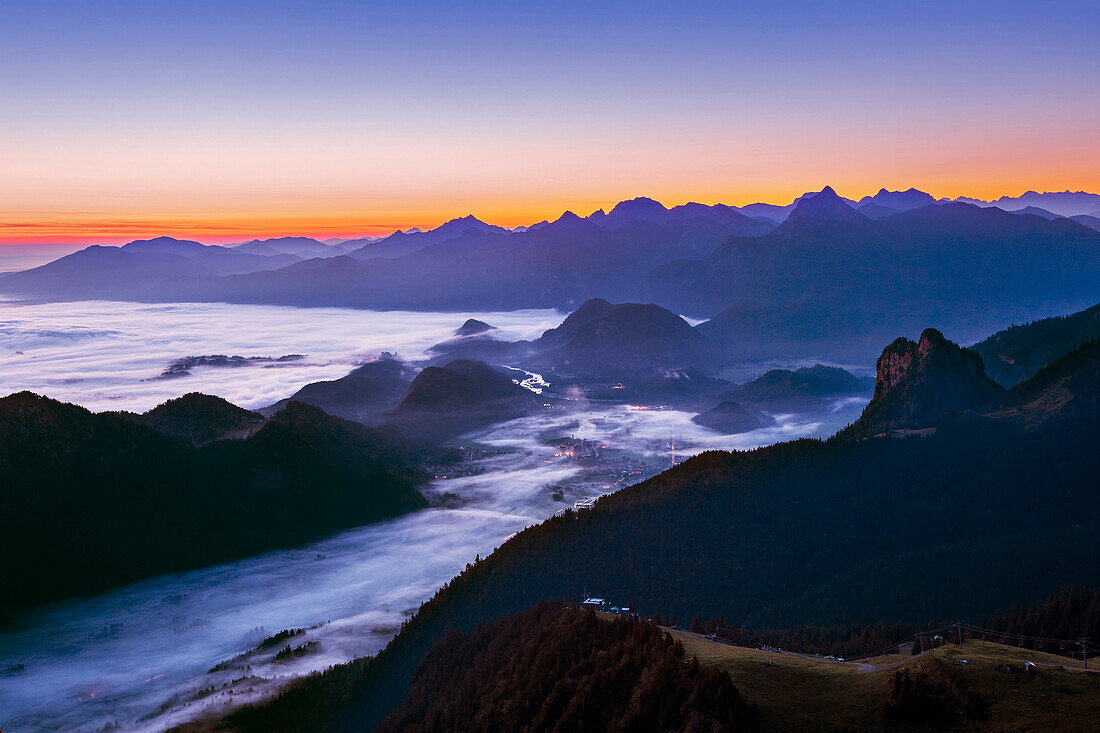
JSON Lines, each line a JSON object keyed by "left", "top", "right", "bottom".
{"left": 970, "top": 304, "right": 1100, "bottom": 387}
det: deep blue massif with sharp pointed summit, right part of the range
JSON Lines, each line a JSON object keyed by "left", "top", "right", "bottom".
{"left": 647, "top": 197, "right": 1100, "bottom": 358}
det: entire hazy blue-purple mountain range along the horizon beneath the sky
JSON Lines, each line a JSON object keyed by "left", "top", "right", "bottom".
{"left": 8, "top": 187, "right": 1100, "bottom": 358}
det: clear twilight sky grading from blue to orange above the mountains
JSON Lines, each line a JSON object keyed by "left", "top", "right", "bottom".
{"left": 0, "top": 0, "right": 1100, "bottom": 242}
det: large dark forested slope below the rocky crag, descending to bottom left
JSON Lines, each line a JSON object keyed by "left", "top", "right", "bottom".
{"left": 223, "top": 332, "right": 1100, "bottom": 730}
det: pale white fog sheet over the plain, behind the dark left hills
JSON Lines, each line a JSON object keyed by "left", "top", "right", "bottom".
{"left": 0, "top": 300, "right": 562, "bottom": 412}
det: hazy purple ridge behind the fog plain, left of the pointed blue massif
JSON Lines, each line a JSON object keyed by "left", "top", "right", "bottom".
{"left": 0, "top": 195, "right": 773, "bottom": 310}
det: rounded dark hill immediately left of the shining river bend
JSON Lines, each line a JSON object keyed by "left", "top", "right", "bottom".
{"left": 382, "top": 359, "right": 539, "bottom": 441}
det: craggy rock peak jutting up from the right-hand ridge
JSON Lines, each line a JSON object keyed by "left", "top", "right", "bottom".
{"left": 855, "top": 328, "right": 1004, "bottom": 435}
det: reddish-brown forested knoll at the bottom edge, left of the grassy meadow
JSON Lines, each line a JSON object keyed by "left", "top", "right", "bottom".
{"left": 377, "top": 602, "right": 758, "bottom": 733}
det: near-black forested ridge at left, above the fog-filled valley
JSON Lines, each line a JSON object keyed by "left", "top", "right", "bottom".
{"left": 0, "top": 392, "right": 426, "bottom": 613}
